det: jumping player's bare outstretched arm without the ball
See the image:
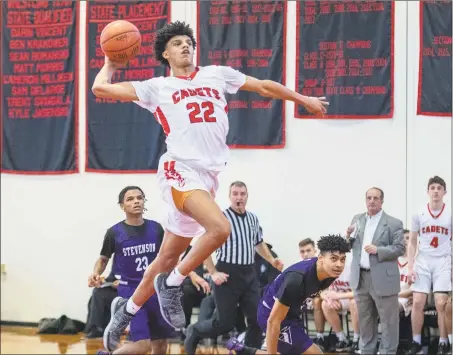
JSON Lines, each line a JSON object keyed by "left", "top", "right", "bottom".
{"left": 240, "top": 76, "right": 329, "bottom": 117}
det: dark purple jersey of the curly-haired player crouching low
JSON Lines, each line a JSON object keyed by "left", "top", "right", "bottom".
{"left": 261, "top": 258, "right": 335, "bottom": 319}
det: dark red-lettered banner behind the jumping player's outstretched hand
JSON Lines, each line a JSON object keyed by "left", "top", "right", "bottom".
{"left": 294, "top": 0, "right": 395, "bottom": 119}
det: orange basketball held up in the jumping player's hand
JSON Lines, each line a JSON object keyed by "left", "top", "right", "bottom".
{"left": 100, "top": 20, "right": 142, "bottom": 61}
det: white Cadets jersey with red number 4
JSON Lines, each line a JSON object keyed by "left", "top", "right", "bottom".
{"left": 411, "top": 204, "right": 451, "bottom": 257}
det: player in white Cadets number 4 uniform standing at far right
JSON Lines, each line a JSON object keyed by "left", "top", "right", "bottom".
{"left": 407, "top": 176, "right": 452, "bottom": 354}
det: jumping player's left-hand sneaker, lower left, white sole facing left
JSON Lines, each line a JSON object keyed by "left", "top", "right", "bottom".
{"left": 104, "top": 297, "right": 133, "bottom": 351}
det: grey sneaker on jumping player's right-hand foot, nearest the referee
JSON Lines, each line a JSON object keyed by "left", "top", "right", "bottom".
{"left": 154, "top": 272, "right": 186, "bottom": 331}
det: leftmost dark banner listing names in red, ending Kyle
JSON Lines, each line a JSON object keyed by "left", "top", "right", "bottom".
{"left": 0, "top": 1, "right": 79, "bottom": 175}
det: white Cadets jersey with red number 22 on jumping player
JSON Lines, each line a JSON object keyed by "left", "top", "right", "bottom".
{"left": 131, "top": 65, "right": 246, "bottom": 171}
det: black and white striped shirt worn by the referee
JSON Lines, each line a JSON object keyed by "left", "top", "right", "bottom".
{"left": 216, "top": 207, "right": 263, "bottom": 265}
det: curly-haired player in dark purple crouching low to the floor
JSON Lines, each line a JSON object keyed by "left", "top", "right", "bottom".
{"left": 226, "top": 235, "right": 352, "bottom": 355}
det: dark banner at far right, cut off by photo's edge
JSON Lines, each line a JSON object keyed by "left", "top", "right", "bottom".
{"left": 417, "top": 0, "right": 452, "bottom": 117}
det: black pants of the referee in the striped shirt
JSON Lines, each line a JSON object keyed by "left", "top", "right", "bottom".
{"left": 194, "top": 262, "right": 262, "bottom": 349}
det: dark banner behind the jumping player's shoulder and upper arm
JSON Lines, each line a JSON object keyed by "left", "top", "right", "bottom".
{"left": 197, "top": 0, "right": 286, "bottom": 148}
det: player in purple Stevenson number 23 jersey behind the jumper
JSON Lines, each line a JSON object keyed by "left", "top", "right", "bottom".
{"left": 98, "top": 186, "right": 206, "bottom": 354}
